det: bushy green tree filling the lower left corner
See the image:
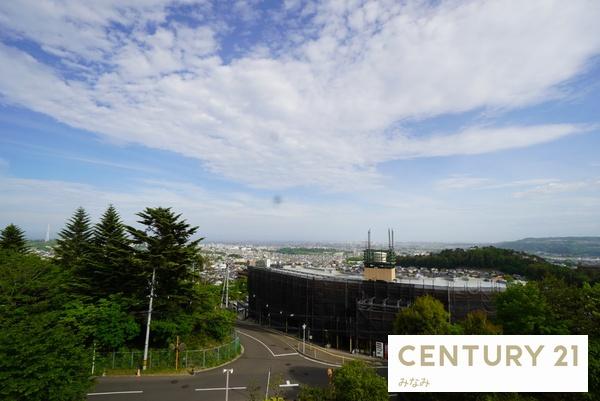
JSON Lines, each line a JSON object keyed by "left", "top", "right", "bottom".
{"left": 0, "top": 252, "right": 91, "bottom": 401}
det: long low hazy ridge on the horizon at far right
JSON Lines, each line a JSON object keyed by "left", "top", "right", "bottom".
{"left": 494, "top": 237, "right": 600, "bottom": 257}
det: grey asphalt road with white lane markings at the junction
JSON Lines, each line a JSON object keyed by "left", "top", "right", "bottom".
{"left": 88, "top": 325, "right": 336, "bottom": 401}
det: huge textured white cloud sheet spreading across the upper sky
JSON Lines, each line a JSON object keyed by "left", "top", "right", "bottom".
{"left": 0, "top": 0, "right": 600, "bottom": 190}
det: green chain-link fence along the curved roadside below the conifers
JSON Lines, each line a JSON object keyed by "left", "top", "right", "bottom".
{"left": 93, "top": 337, "right": 242, "bottom": 374}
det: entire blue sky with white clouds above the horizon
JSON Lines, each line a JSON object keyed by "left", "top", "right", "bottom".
{"left": 0, "top": 0, "right": 600, "bottom": 242}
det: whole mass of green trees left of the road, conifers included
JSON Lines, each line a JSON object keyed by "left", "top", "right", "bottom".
{"left": 0, "top": 206, "right": 235, "bottom": 401}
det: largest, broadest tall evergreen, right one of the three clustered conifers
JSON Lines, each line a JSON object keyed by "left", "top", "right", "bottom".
{"left": 127, "top": 207, "right": 203, "bottom": 306}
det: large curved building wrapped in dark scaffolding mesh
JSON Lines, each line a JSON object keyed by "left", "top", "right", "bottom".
{"left": 248, "top": 230, "right": 504, "bottom": 354}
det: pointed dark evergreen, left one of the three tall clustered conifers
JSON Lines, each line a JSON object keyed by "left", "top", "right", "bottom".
{"left": 54, "top": 207, "right": 92, "bottom": 269}
